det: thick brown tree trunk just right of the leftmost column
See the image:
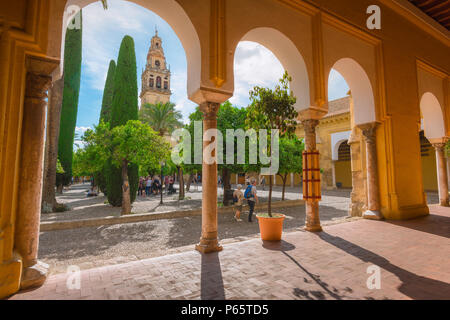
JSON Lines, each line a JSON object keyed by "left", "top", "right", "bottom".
{"left": 42, "top": 75, "right": 64, "bottom": 212}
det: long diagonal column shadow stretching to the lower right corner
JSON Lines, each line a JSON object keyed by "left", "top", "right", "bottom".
{"left": 317, "top": 232, "right": 450, "bottom": 300}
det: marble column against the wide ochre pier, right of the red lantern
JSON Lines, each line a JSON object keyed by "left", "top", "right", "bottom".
{"left": 359, "top": 122, "right": 383, "bottom": 220}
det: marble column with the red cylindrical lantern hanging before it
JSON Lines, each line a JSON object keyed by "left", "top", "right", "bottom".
{"left": 302, "top": 119, "right": 322, "bottom": 232}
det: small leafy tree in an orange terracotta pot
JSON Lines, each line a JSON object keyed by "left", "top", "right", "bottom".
{"left": 247, "top": 72, "right": 298, "bottom": 241}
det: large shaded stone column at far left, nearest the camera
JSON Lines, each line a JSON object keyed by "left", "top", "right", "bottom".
{"left": 14, "top": 72, "right": 52, "bottom": 289}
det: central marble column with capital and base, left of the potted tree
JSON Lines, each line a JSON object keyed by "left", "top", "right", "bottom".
{"left": 195, "top": 102, "right": 222, "bottom": 253}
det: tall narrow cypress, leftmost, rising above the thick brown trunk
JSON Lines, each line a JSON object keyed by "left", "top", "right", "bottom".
{"left": 58, "top": 11, "right": 82, "bottom": 185}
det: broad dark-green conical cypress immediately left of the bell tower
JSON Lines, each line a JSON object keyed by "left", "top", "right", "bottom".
{"left": 105, "top": 36, "right": 139, "bottom": 207}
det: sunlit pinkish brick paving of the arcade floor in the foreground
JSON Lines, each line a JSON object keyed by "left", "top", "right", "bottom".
{"left": 11, "top": 206, "right": 450, "bottom": 300}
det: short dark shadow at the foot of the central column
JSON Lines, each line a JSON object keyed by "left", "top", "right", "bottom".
{"left": 200, "top": 252, "right": 225, "bottom": 300}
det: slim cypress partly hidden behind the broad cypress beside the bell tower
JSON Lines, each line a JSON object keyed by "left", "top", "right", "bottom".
{"left": 95, "top": 60, "right": 116, "bottom": 194}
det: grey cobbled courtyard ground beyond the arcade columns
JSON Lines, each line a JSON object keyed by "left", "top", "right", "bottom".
{"left": 39, "top": 185, "right": 437, "bottom": 274}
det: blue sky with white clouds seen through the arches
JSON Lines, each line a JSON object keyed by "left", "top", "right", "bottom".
{"left": 76, "top": 0, "right": 348, "bottom": 135}
